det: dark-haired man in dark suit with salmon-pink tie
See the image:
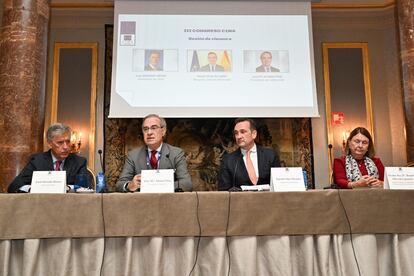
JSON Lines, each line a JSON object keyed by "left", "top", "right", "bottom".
{"left": 218, "top": 118, "right": 280, "bottom": 191}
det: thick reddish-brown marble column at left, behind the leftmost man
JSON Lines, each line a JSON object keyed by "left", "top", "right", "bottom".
{"left": 0, "top": 0, "right": 50, "bottom": 192}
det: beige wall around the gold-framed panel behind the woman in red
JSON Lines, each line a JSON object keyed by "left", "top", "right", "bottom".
{"left": 312, "top": 8, "right": 406, "bottom": 183}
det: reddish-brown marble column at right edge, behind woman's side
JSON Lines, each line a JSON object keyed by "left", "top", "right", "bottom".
{"left": 396, "top": 0, "right": 414, "bottom": 163}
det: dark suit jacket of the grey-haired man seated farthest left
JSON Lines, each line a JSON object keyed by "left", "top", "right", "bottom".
{"left": 7, "top": 150, "right": 88, "bottom": 193}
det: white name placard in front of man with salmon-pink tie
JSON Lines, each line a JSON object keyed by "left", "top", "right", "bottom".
{"left": 270, "top": 167, "right": 306, "bottom": 192}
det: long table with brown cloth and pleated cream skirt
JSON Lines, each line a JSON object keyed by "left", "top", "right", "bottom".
{"left": 0, "top": 190, "right": 414, "bottom": 276}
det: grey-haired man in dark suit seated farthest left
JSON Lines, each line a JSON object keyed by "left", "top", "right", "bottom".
{"left": 7, "top": 123, "right": 88, "bottom": 193}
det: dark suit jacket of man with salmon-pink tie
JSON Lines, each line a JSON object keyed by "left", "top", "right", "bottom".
{"left": 218, "top": 145, "right": 280, "bottom": 191}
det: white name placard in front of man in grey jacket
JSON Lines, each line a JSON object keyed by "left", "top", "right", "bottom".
{"left": 141, "top": 169, "right": 174, "bottom": 193}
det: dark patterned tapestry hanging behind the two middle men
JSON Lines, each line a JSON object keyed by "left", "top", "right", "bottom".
{"left": 104, "top": 25, "right": 314, "bottom": 191}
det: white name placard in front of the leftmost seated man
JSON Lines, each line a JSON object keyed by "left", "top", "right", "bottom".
{"left": 30, "top": 171, "right": 66, "bottom": 194}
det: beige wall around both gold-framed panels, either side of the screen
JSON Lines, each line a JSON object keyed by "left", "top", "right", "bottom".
{"left": 37, "top": 5, "right": 406, "bottom": 188}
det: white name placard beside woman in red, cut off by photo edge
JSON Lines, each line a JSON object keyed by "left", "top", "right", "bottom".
{"left": 384, "top": 167, "right": 414, "bottom": 190}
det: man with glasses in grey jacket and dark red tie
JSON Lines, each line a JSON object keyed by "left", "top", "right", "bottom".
{"left": 116, "top": 114, "right": 192, "bottom": 192}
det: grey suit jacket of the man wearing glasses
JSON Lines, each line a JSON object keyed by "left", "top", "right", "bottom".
{"left": 116, "top": 143, "right": 193, "bottom": 192}
